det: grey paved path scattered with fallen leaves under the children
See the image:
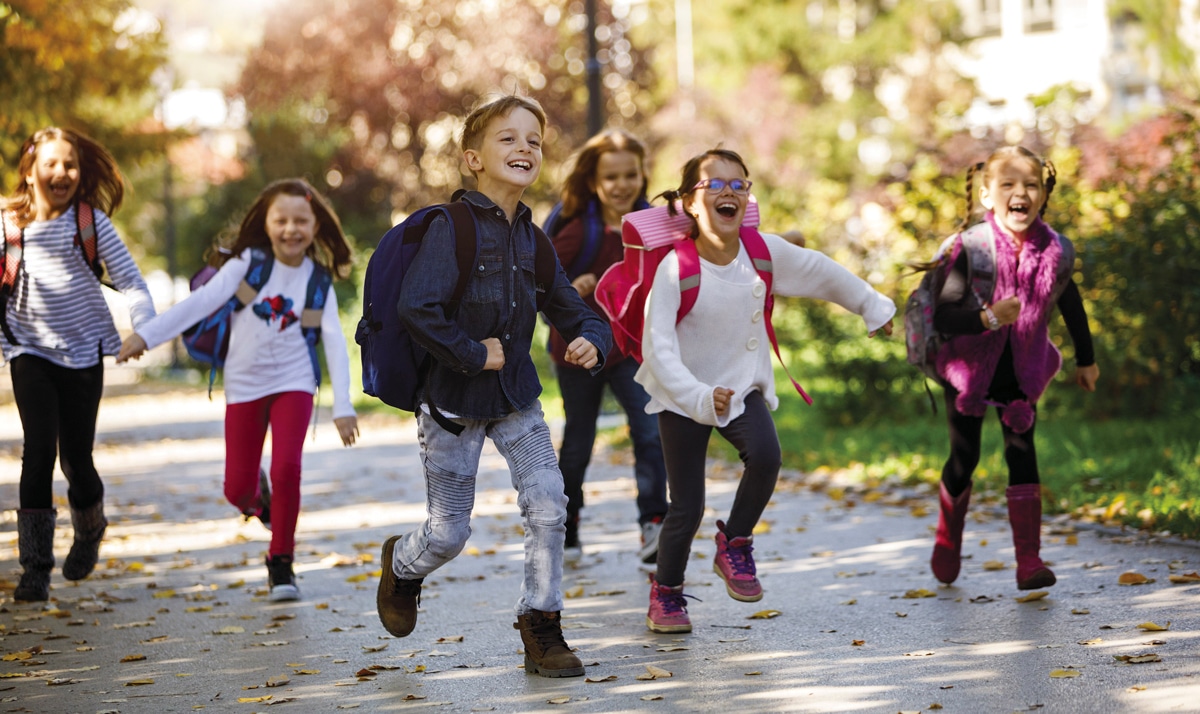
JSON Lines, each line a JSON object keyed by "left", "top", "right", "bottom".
{"left": 0, "top": 389, "right": 1200, "bottom": 714}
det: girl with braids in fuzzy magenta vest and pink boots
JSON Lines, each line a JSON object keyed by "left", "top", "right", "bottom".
{"left": 931, "top": 146, "right": 1100, "bottom": 590}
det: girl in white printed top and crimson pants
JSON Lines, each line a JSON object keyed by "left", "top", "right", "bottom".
{"left": 118, "top": 179, "right": 359, "bottom": 601}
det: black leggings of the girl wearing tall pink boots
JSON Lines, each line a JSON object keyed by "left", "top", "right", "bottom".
{"left": 942, "top": 385, "right": 1039, "bottom": 496}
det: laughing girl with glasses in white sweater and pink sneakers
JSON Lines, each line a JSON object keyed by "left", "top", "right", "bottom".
{"left": 636, "top": 149, "right": 895, "bottom": 632}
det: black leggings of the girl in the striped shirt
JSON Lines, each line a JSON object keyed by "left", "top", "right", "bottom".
{"left": 8, "top": 354, "right": 104, "bottom": 510}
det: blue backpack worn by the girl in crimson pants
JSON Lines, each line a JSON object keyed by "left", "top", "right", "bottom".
{"left": 182, "top": 248, "right": 334, "bottom": 400}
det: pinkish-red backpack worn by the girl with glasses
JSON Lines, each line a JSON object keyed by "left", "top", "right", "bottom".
{"left": 595, "top": 199, "right": 812, "bottom": 404}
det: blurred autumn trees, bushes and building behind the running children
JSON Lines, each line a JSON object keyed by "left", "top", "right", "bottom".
{"left": 0, "top": 0, "right": 1200, "bottom": 530}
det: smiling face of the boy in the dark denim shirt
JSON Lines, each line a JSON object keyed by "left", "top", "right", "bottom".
{"left": 463, "top": 107, "right": 541, "bottom": 189}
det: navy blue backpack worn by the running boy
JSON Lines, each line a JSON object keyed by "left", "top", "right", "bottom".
{"left": 354, "top": 192, "right": 558, "bottom": 412}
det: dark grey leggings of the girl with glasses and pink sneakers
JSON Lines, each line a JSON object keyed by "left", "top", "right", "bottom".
{"left": 655, "top": 391, "right": 782, "bottom": 587}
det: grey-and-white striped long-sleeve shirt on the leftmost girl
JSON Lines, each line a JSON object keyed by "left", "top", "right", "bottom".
{"left": 0, "top": 206, "right": 155, "bottom": 370}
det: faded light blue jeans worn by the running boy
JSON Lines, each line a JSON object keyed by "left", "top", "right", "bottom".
{"left": 392, "top": 403, "right": 566, "bottom": 616}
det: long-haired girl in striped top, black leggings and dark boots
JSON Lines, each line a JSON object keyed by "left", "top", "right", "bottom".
{"left": 0, "top": 127, "right": 154, "bottom": 601}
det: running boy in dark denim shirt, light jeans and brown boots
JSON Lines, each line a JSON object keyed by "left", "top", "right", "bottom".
{"left": 376, "top": 96, "right": 612, "bottom": 677}
